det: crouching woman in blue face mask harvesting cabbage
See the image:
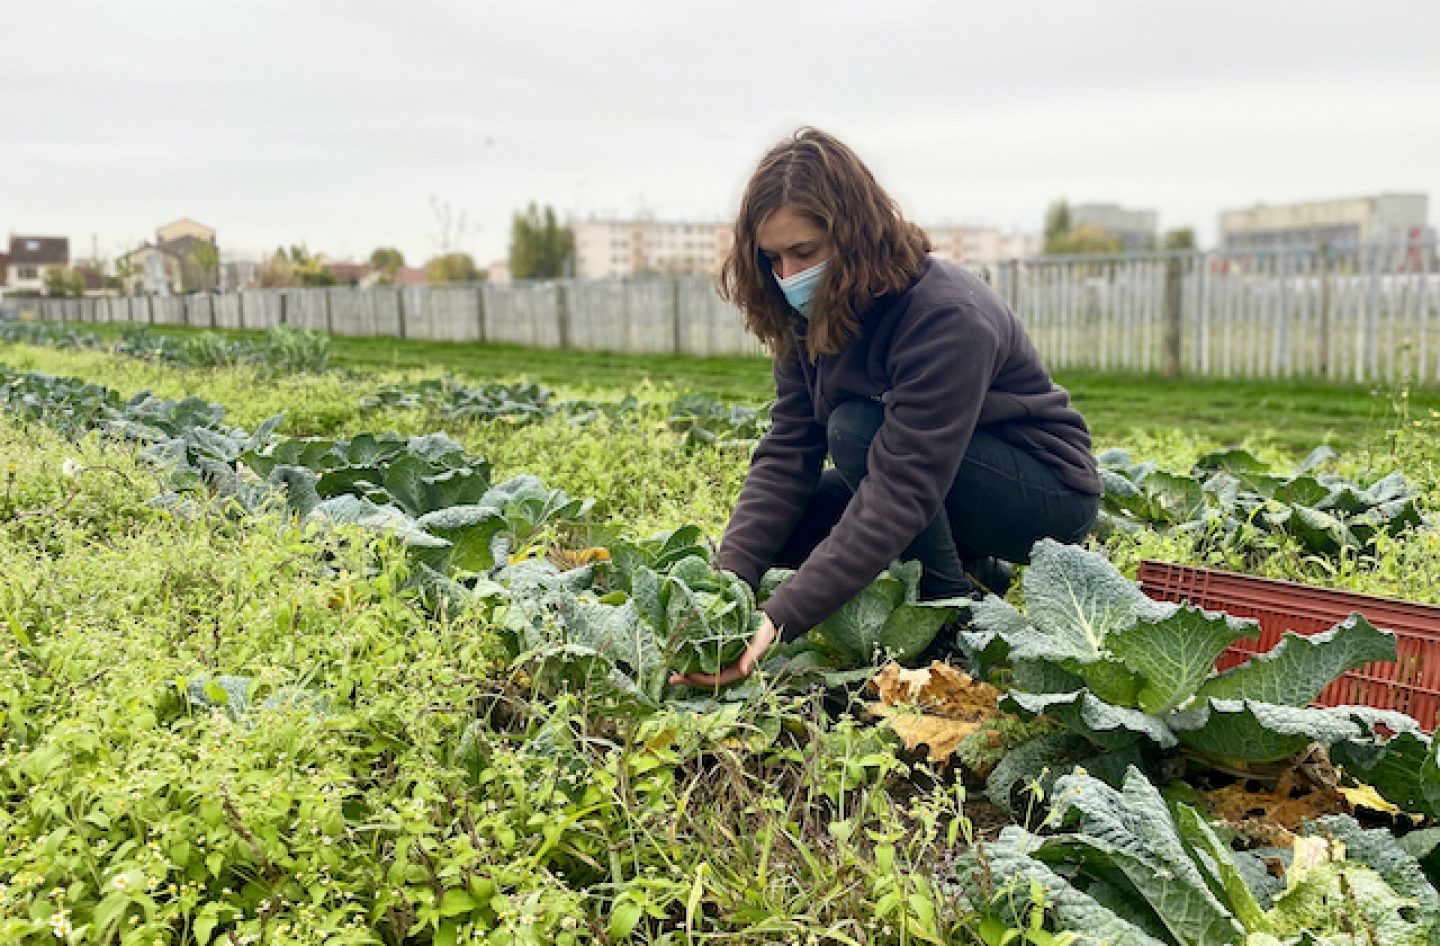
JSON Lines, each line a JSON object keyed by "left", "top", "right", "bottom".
{"left": 674, "top": 128, "right": 1102, "bottom": 685}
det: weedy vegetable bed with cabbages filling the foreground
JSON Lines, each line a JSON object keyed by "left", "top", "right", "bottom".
{"left": 0, "top": 341, "right": 1440, "bottom": 945}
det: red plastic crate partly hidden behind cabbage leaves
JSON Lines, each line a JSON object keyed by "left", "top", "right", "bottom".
{"left": 1140, "top": 562, "right": 1440, "bottom": 733}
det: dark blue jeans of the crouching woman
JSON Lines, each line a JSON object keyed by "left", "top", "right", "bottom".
{"left": 775, "top": 399, "right": 1100, "bottom": 598}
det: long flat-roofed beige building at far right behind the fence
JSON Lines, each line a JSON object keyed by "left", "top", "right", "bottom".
{"left": 1220, "top": 194, "right": 1434, "bottom": 252}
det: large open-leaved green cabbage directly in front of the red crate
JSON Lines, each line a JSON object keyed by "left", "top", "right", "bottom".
{"left": 965, "top": 540, "right": 1416, "bottom": 767}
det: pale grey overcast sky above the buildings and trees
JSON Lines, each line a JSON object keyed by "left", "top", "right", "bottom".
{"left": 0, "top": 0, "right": 1440, "bottom": 265}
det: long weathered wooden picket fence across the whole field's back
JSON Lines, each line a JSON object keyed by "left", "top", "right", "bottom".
{"left": 19, "top": 245, "right": 1440, "bottom": 384}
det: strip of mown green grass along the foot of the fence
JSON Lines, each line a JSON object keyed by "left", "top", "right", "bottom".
{"left": 22, "top": 324, "right": 1440, "bottom": 456}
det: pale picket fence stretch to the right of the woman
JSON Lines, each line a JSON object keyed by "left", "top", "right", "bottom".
{"left": 986, "top": 245, "right": 1440, "bottom": 384}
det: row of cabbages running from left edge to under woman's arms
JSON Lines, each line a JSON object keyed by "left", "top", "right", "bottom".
{"left": 0, "top": 361, "right": 969, "bottom": 707}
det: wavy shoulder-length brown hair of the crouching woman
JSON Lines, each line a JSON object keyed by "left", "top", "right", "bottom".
{"left": 717, "top": 128, "right": 930, "bottom": 359}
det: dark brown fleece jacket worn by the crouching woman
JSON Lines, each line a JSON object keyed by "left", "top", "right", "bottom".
{"left": 720, "top": 258, "right": 1102, "bottom": 641}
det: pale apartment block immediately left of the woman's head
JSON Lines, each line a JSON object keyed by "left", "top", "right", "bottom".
{"left": 572, "top": 217, "right": 734, "bottom": 279}
